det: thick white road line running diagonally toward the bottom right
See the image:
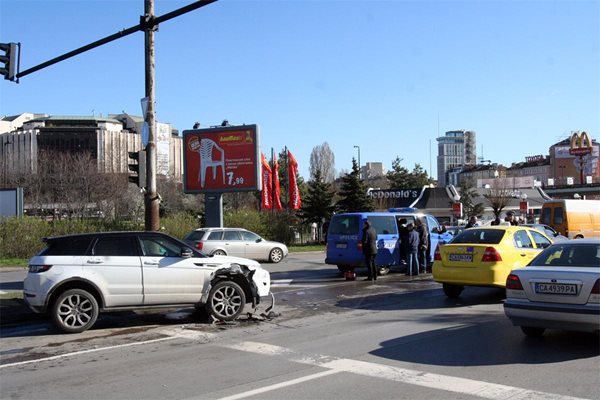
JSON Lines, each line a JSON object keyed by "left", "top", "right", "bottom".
{"left": 222, "top": 342, "right": 579, "bottom": 400}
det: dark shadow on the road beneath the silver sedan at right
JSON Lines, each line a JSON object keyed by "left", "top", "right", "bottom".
{"left": 371, "top": 315, "right": 600, "bottom": 367}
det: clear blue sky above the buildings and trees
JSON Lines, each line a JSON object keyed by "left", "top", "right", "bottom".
{"left": 0, "top": 0, "right": 600, "bottom": 179}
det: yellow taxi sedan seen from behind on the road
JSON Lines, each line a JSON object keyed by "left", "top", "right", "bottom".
{"left": 432, "top": 225, "right": 552, "bottom": 298}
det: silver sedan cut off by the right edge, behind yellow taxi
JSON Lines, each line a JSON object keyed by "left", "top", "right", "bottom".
{"left": 504, "top": 239, "right": 600, "bottom": 336}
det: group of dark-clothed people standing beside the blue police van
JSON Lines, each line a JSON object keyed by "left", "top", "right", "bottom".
{"left": 362, "top": 218, "right": 429, "bottom": 281}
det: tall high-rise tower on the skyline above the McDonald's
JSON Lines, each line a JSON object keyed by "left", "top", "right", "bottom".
{"left": 437, "top": 129, "right": 477, "bottom": 186}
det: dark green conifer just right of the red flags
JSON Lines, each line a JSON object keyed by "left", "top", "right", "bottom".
{"left": 300, "top": 170, "right": 335, "bottom": 238}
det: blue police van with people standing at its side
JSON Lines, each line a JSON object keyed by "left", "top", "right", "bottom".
{"left": 325, "top": 207, "right": 452, "bottom": 275}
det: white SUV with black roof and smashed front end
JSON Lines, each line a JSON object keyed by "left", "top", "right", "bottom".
{"left": 23, "top": 232, "right": 270, "bottom": 333}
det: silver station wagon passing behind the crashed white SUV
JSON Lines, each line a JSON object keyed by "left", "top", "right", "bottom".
{"left": 183, "top": 228, "right": 288, "bottom": 263}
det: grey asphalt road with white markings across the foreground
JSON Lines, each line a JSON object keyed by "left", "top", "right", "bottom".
{"left": 0, "top": 254, "right": 600, "bottom": 400}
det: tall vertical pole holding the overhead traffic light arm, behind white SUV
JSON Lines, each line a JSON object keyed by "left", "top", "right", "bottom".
{"left": 144, "top": 0, "right": 160, "bottom": 231}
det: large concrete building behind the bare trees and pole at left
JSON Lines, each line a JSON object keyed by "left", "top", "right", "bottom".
{"left": 0, "top": 114, "right": 183, "bottom": 181}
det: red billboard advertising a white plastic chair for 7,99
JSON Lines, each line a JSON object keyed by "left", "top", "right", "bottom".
{"left": 183, "top": 125, "right": 261, "bottom": 193}
